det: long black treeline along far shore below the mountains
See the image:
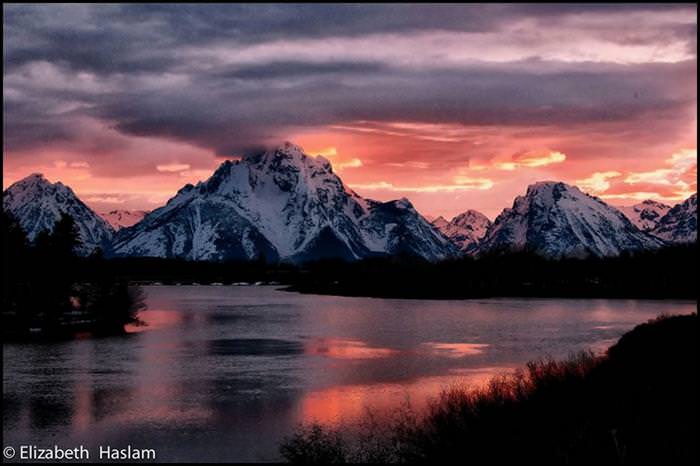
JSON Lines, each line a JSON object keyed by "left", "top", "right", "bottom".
{"left": 30, "top": 240, "right": 698, "bottom": 299}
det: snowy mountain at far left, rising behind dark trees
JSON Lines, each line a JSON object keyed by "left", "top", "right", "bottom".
{"left": 2, "top": 173, "right": 114, "bottom": 254}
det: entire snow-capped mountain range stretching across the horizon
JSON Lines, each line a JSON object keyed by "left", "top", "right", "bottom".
{"left": 3, "top": 143, "right": 697, "bottom": 263}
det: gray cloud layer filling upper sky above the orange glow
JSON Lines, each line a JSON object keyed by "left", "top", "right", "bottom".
{"left": 3, "top": 4, "right": 697, "bottom": 155}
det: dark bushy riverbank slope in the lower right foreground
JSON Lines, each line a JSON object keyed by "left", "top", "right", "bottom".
{"left": 280, "top": 314, "right": 698, "bottom": 464}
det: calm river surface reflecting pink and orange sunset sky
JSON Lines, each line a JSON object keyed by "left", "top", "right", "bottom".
{"left": 3, "top": 286, "right": 695, "bottom": 461}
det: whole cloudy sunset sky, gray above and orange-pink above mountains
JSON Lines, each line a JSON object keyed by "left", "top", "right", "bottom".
{"left": 3, "top": 4, "right": 697, "bottom": 219}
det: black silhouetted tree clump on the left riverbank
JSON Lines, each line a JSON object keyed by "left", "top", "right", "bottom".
{"left": 2, "top": 211, "right": 143, "bottom": 340}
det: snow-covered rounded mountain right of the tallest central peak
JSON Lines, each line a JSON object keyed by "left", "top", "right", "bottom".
{"left": 479, "top": 181, "right": 663, "bottom": 258}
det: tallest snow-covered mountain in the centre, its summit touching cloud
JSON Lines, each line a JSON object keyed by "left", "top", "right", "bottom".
{"left": 113, "top": 143, "right": 457, "bottom": 262}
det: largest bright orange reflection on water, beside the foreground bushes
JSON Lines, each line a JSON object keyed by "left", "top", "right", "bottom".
{"left": 297, "top": 367, "right": 513, "bottom": 425}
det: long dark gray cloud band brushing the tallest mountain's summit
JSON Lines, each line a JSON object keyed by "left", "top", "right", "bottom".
{"left": 69, "top": 58, "right": 695, "bottom": 155}
